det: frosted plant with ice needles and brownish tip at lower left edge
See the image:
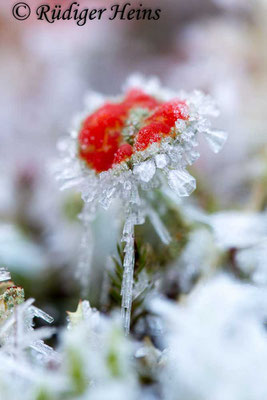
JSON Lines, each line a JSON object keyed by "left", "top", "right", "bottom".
{"left": 0, "top": 269, "right": 59, "bottom": 399}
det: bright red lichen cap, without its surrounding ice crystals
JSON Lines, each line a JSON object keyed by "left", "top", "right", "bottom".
{"left": 78, "top": 89, "right": 191, "bottom": 173}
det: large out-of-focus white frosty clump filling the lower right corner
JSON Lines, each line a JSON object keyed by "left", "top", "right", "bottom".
{"left": 153, "top": 275, "right": 267, "bottom": 400}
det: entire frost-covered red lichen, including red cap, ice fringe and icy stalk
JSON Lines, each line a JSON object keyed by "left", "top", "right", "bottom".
{"left": 57, "top": 76, "right": 226, "bottom": 331}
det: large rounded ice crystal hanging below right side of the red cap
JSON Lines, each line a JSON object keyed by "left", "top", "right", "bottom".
{"left": 168, "top": 169, "right": 196, "bottom": 197}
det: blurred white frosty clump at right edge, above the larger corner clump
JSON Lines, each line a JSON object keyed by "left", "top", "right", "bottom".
{"left": 183, "top": 206, "right": 267, "bottom": 285}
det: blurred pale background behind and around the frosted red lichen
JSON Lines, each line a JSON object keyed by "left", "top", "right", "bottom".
{"left": 0, "top": 0, "right": 267, "bottom": 323}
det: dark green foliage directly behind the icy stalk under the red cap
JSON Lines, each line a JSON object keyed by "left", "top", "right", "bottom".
{"left": 105, "top": 191, "right": 191, "bottom": 331}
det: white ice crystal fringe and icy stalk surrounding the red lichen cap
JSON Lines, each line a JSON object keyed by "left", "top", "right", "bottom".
{"left": 56, "top": 75, "right": 226, "bottom": 330}
